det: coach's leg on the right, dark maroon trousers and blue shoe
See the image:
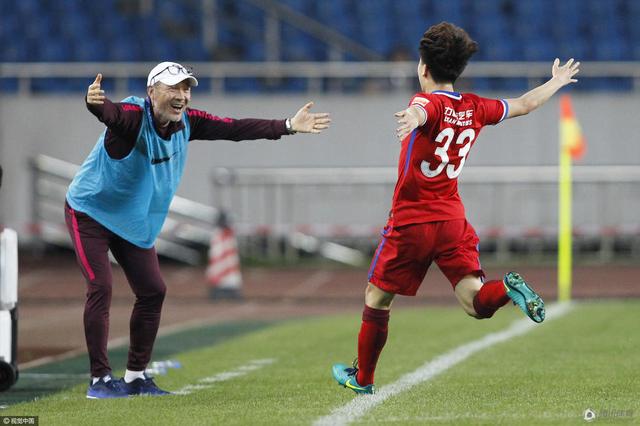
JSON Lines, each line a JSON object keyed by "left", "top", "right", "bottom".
{"left": 111, "top": 238, "right": 168, "bottom": 395}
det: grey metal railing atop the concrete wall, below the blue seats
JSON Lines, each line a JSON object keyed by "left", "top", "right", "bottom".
{"left": 0, "top": 61, "right": 640, "bottom": 95}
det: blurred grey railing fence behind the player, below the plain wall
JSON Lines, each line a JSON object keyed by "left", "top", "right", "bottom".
{"left": 213, "top": 166, "right": 640, "bottom": 262}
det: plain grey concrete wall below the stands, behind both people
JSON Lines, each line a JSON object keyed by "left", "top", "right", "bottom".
{"left": 0, "top": 92, "right": 640, "bottom": 238}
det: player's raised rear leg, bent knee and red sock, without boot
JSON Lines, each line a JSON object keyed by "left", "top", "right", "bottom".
{"left": 455, "top": 275, "right": 509, "bottom": 319}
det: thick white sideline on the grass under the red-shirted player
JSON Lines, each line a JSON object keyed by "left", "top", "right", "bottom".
{"left": 313, "top": 303, "right": 573, "bottom": 426}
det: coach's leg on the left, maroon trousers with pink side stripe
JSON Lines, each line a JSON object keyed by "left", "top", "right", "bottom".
{"left": 65, "top": 204, "right": 127, "bottom": 398}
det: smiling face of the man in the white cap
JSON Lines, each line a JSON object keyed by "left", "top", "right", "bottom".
{"left": 147, "top": 80, "right": 191, "bottom": 127}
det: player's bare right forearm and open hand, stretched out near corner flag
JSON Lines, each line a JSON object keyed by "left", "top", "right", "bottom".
{"left": 505, "top": 58, "right": 580, "bottom": 118}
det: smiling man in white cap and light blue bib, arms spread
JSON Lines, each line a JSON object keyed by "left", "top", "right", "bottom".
{"left": 65, "top": 62, "right": 330, "bottom": 398}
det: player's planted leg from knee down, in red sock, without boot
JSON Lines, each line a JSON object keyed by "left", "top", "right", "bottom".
{"left": 356, "top": 283, "right": 395, "bottom": 386}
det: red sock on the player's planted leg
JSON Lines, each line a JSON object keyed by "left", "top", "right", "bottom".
{"left": 356, "top": 305, "right": 389, "bottom": 386}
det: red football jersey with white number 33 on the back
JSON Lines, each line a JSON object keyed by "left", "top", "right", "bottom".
{"left": 390, "top": 90, "right": 509, "bottom": 226}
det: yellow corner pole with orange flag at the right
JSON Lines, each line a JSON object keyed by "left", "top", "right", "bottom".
{"left": 558, "top": 95, "right": 586, "bottom": 302}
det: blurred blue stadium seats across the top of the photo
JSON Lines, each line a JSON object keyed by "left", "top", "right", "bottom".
{"left": 0, "top": 0, "right": 640, "bottom": 93}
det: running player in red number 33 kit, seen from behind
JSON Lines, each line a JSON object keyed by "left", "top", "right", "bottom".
{"left": 333, "top": 22, "right": 579, "bottom": 394}
